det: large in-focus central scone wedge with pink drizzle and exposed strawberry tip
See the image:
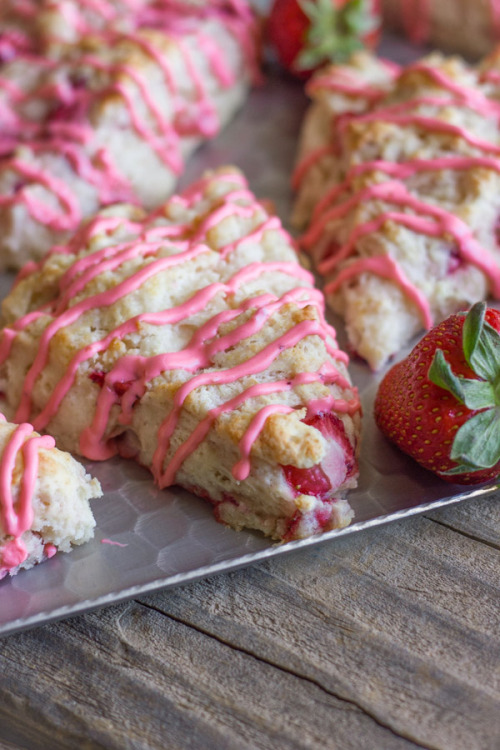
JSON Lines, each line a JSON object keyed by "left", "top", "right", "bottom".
{"left": 0, "top": 168, "right": 360, "bottom": 539}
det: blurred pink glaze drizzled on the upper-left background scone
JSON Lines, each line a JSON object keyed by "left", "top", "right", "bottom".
{"left": 0, "top": 0, "right": 262, "bottom": 232}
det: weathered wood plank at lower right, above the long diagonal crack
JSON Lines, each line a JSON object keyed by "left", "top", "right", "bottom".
{"left": 140, "top": 500, "right": 500, "bottom": 749}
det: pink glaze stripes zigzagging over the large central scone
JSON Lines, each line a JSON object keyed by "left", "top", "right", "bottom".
{"left": 0, "top": 172, "right": 360, "bottom": 496}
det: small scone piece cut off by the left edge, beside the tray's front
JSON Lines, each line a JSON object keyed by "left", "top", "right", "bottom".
{"left": 0, "top": 418, "right": 102, "bottom": 578}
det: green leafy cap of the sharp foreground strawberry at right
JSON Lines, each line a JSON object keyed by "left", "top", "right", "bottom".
{"left": 428, "top": 302, "right": 500, "bottom": 475}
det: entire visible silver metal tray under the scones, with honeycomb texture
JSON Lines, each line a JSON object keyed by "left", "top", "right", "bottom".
{"left": 0, "top": 41, "right": 499, "bottom": 635}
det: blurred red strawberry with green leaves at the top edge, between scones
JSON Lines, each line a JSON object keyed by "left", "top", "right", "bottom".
{"left": 267, "top": 0, "right": 380, "bottom": 77}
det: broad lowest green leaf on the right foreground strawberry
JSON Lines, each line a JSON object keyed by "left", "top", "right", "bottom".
{"left": 450, "top": 408, "right": 500, "bottom": 469}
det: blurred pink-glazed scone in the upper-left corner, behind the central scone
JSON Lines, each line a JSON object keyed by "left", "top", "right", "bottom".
{"left": 0, "top": 0, "right": 257, "bottom": 268}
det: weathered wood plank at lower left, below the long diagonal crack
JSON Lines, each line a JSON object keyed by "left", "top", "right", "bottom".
{"left": 0, "top": 604, "right": 422, "bottom": 750}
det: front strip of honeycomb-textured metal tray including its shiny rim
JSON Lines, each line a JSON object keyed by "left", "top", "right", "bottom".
{"left": 0, "top": 376, "right": 498, "bottom": 634}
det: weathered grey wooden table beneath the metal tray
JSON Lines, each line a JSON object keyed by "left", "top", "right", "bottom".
{"left": 0, "top": 494, "right": 500, "bottom": 750}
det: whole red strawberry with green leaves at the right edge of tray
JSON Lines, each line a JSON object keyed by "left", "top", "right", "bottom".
{"left": 375, "top": 302, "right": 500, "bottom": 484}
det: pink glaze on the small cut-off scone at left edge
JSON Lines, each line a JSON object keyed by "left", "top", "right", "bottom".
{"left": 0, "top": 420, "right": 55, "bottom": 573}
